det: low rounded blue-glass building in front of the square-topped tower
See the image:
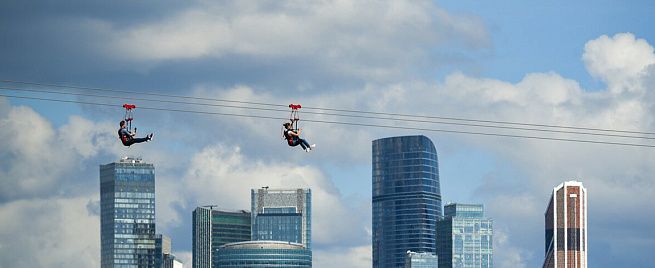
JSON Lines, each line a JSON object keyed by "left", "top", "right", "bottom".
{"left": 217, "top": 241, "right": 312, "bottom": 268}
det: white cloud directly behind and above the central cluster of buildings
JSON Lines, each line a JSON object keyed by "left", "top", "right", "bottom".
{"left": 174, "top": 145, "right": 369, "bottom": 247}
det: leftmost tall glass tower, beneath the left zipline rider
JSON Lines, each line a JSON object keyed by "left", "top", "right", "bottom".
{"left": 100, "top": 157, "right": 156, "bottom": 268}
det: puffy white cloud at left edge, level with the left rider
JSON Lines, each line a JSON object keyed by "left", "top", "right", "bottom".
{"left": 0, "top": 102, "right": 122, "bottom": 200}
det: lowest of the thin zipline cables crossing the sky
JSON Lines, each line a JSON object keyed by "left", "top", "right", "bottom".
{"left": 0, "top": 94, "right": 655, "bottom": 148}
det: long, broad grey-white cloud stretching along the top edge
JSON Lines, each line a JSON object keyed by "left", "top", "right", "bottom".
{"left": 95, "top": 1, "right": 491, "bottom": 79}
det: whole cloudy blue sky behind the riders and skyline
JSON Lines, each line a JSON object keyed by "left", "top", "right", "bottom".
{"left": 0, "top": 0, "right": 655, "bottom": 268}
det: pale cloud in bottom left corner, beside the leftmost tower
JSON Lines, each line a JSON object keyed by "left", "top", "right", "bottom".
{"left": 0, "top": 194, "right": 100, "bottom": 267}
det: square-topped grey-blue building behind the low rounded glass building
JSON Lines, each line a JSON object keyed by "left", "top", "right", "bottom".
{"left": 251, "top": 187, "right": 312, "bottom": 249}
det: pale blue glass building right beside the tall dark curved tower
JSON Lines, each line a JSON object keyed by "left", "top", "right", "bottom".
{"left": 437, "top": 203, "right": 493, "bottom": 268}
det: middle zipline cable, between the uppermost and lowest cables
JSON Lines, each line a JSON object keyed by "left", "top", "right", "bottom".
{"left": 0, "top": 86, "right": 655, "bottom": 140}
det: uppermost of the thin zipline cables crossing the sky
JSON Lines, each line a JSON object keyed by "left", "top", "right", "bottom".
{"left": 0, "top": 80, "right": 655, "bottom": 135}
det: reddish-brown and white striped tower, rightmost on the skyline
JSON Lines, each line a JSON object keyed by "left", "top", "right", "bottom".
{"left": 542, "top": 181, "right": 587, "bottom": 268}
